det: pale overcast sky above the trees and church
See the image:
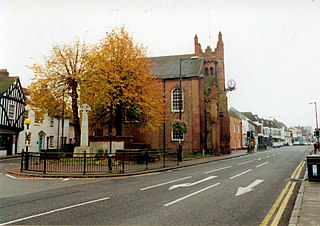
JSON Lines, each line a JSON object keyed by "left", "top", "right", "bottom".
{"left": 0, "top": 0, "right": 320, "bottom": 127}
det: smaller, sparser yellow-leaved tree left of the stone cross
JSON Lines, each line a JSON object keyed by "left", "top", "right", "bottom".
{"left": 28, "top": 41, "right": 90, "bottom": 145}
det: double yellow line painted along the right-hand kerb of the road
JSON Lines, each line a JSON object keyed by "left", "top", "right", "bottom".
{"left": 260, "top": 161, "right": 305, "bottom": 226}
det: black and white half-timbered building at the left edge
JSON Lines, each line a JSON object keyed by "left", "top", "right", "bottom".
{"left": 0, "top": 69, "right": 26, "bottom": 156}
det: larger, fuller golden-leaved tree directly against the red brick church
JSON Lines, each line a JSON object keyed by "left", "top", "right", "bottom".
{"left": 81, "top": 27, "right": 163, "bottom": 136}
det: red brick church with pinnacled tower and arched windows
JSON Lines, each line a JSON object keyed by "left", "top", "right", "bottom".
{"left": 124, "top": 32, "right": 230, "bottom": 155}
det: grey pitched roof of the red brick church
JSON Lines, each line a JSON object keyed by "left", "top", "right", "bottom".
{"left": 149, "top": 54, "right": 203, "bottom": 79}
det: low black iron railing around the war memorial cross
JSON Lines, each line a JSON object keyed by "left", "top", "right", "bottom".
{"left": 20, "top": 150, "right": 178, "bottom": 175}
